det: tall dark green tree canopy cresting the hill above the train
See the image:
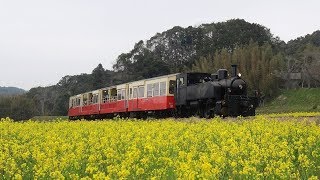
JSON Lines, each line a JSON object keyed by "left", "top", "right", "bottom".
{"left": 113, "top": 19, "right": 283, "bottom": 77}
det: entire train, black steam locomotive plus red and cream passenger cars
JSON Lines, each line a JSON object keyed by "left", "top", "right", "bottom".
{"left": 68, "top": 65, "right": 258, "bottom": 119}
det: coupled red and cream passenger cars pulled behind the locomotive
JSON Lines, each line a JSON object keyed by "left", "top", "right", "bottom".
{"left": 68, "top": 74, "right": 176, "bottom": 119}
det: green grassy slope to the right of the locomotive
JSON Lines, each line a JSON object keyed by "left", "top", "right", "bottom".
{"left": 257, "top": 88, "right": 320, "bottom": 114}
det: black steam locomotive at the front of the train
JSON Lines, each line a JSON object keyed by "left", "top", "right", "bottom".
{"left": 175, "top": 65, "right": 258, "bottom": 118}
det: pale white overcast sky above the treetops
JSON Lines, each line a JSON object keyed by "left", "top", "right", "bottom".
{"left": 0, "top": 0, "right": 320, "bottom": 90}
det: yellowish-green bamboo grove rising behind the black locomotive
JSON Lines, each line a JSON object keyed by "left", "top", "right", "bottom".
{"left": 191, "top": 41, "right": 284, "bottom": 97}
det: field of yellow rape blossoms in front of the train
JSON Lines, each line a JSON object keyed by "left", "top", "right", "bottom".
{"left": 0, "top": 113, "right": 320, "bottom": 179}
